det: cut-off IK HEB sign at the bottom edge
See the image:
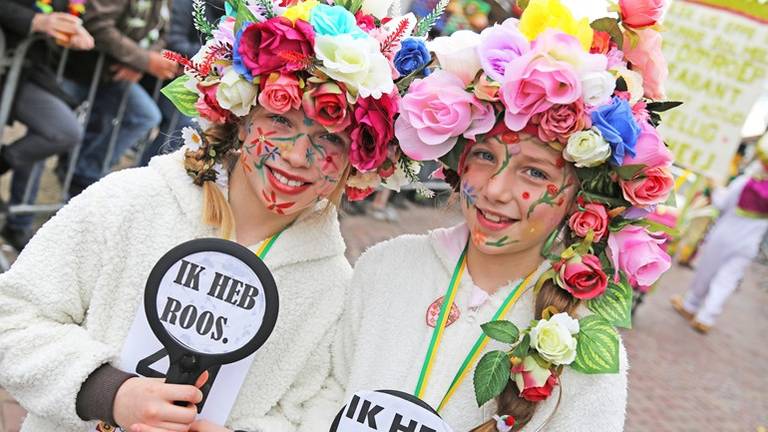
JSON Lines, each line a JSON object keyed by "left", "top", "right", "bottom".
{"left": 330, "top": 390, "right": 452, "bottom": 432}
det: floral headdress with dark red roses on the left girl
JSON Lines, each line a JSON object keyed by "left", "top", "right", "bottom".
{"left": 163, "top": 0, "right": 447, "bottom": 199}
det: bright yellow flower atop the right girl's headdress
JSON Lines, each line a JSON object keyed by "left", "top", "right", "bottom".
{"left": 520, "top": 0, "right": 594, "bottom": 51}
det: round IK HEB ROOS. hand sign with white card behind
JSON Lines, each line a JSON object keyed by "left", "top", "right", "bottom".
{"left": 92, "top": 238, "right": 279, "bottom": 424}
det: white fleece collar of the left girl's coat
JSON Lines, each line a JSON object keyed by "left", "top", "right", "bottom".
{"left": 149, "top": 148, "right": 346, "bottom": 270}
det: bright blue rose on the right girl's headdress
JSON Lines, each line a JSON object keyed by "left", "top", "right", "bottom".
{"left": 591, "top": 96, "right": 640, "bottom": 166}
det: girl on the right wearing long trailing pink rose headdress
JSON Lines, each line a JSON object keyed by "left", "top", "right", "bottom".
{"left": 335, "top": 0, "right": 674, "bottom": 432}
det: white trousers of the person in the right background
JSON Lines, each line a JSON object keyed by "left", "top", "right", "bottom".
{"left": 684, "top": 255, "right": 752, "bottom": 326}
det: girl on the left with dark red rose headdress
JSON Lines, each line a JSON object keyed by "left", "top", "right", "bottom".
{"left": 0, "top": 0, "right": 414, "bottom": 432}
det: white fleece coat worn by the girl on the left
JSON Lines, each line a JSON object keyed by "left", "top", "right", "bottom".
{"left": 0, "top": 152, "right": 351, "bottom": 432}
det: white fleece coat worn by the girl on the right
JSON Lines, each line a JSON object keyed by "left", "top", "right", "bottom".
{"left": 334, "top": 225, "right": 627, "bottom": 432}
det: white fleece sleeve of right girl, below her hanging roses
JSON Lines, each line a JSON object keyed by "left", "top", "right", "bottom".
{"left": 523, "top": 341, "right": 629, "bottom": 432}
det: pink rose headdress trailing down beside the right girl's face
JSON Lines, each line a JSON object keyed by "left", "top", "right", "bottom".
{"left": 395, "top": 0, "right": 679, "bottom": 414}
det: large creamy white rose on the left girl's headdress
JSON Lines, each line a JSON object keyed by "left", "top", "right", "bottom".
{"left": 315, "top": 34, "right": 395, "bottom": 99}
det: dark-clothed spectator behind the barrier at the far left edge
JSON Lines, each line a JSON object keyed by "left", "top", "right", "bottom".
{"left": 0, "top": 0, "right": 94, "bottom": 250}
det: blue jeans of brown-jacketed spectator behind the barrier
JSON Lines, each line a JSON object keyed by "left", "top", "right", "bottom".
{"left": 66, "top": 81, "right": 162, "bottom": 195}
